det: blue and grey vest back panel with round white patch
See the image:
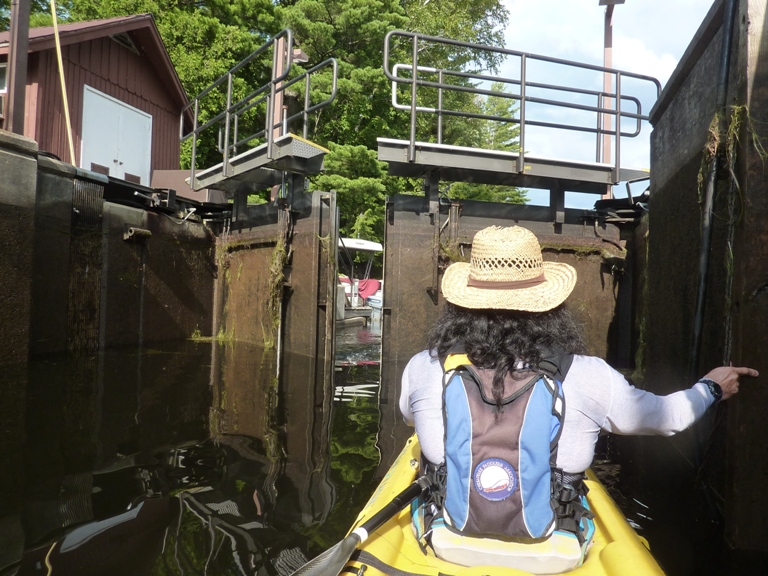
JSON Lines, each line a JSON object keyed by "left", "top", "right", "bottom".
{"left": 443, "top": 354, "right": 565, "bottom": 539}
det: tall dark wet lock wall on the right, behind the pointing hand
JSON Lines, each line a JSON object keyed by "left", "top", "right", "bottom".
{"left": 643, "top": 0, "right": 768, "bottom": 552}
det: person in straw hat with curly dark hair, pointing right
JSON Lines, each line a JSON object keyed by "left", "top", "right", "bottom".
{"left": 400, "top": 226, "right": 758, "bottom": 565}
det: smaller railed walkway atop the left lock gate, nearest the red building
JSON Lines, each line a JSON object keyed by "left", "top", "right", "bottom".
{"left": 180, "top": 29, "right": 338, "bottom": 203}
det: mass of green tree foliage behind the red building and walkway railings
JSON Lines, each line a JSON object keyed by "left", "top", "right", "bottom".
{"left": 0, "top": 0, "right": 525, "bottom": 240}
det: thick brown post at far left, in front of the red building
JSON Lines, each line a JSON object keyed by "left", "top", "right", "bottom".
{"left": 6, "top": 0, "right": 30, "bottom": 135}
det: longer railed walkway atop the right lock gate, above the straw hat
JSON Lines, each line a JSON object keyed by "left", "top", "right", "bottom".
{"left": 378, "top": 31, "right": 661, "bottom": 208}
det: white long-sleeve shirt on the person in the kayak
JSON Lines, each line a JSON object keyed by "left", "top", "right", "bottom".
{"left": 400, "top": 350, "right": 714, "bottom": 474}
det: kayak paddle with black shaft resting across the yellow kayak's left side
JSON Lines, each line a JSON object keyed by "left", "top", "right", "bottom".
{"left": 291, "top": 476, "right": 430, "bottom": 576}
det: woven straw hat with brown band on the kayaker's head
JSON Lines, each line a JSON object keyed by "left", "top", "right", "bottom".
{"left": 442, "top": 226, "right": 576, "bottom": 312}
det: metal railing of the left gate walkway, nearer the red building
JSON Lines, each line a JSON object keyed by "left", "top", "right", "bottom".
{"left": 179, "top": 29, "right": 338, "bottom": 182}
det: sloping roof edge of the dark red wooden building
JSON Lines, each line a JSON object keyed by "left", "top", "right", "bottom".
{"left": 0, "top": 14, "right": 189, "bottom": 108}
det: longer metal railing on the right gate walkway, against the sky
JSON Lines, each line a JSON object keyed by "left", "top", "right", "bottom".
{"left": 384, "top": 30, "right": 661, "bottom": 182}
